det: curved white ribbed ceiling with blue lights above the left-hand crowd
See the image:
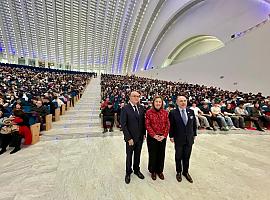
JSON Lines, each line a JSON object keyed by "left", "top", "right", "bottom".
{"left": 0, "top": 0, "right": 268, "bottom": 73}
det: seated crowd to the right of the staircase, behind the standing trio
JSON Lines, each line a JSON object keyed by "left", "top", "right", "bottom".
{"left": 101, "top": 74, "right": 270, "bottom": 132}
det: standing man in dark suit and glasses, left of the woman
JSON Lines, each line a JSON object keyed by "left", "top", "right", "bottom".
{"left": 120, "top": 91, "right": 146, "bottom": 184}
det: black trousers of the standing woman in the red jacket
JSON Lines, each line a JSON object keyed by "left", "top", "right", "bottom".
{"left": 147, "top": 135, "right": 166, "bottom": 174}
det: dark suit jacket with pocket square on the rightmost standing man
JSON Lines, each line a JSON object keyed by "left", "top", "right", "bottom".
{"left": 169, "top": 108, "right": 197, "bottom": 145}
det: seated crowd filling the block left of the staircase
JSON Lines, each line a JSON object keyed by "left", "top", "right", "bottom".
{"left": 0, "top": 64, "right": 96, "bottom": 155}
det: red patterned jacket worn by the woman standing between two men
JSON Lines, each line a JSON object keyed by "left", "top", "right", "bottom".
{"left": 145, "top": 108, "right": 170, "bottom": 137}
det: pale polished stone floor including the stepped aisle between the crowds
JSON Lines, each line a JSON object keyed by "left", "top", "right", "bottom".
{"left": 0, "top": 79, "right": 270, "bottom": 200}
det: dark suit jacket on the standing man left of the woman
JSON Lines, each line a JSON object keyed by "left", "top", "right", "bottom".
{"left": 120, "top": 103, "right": 146, "bottom": 142}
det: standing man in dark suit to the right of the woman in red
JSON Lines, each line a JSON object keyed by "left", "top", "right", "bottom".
{"left": 169, "top": 96, "right": 197, "bottom": 183}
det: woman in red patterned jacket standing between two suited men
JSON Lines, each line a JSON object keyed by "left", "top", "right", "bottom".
{"left": 145, "top": 96, "right": 170, "bottom": 180}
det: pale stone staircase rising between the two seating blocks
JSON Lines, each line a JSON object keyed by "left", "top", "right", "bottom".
{"left": 40, "top": 76, "right": 122, "bottom": 141}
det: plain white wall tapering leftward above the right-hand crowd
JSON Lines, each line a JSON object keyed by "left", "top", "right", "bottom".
{"left": 136, "top": 22, "right": 270, "bottom": 95}
